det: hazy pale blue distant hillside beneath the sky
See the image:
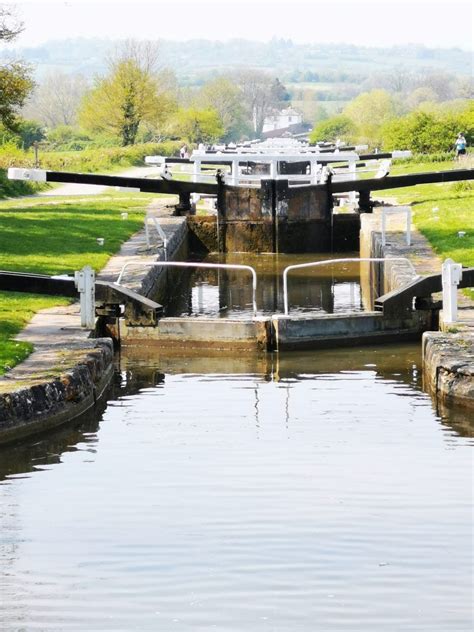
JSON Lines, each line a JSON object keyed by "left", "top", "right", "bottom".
{"left": 0, "top": 38, "right": 472, "bottom": 85}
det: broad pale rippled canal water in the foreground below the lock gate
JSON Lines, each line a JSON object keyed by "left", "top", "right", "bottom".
{"left": 0, "top": 345, "right": 474, "bottom": 632}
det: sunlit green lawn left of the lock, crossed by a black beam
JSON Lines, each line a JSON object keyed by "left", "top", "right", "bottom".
{"left": 0, "top": 194, "right": 156, "bottom": 375}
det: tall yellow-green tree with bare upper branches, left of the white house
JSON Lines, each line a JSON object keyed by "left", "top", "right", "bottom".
{"left": 79, "top": 42, "right": 175, "bottom": 146}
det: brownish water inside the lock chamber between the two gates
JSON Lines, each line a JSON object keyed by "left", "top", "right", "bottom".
{"left": 166, "top": 253, "right": 363, "bottom": 318}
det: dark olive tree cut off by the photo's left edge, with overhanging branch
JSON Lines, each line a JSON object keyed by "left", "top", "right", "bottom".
{"left": 0, "top": 5, "right": 34, "bottom": 131}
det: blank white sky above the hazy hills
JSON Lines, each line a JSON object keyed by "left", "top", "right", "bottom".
{"left": 8, "top": 0, "right": 474, "bottom": 50}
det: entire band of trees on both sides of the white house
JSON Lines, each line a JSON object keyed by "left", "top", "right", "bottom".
{"left": 0, "top": 5, "right": 474, "bottom": 153}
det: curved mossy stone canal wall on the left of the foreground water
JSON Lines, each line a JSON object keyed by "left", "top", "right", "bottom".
{"left": 0, "top": 338, "right": 114, "bottom": 446}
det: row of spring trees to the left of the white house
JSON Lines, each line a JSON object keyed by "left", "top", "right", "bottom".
{"left": 0, "top": 8, "right": 289, "bottom": 149}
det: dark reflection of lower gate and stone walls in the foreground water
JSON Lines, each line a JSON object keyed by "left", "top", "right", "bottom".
{"left": 0, "top": 344, "right": 474, "bottom": 481}
